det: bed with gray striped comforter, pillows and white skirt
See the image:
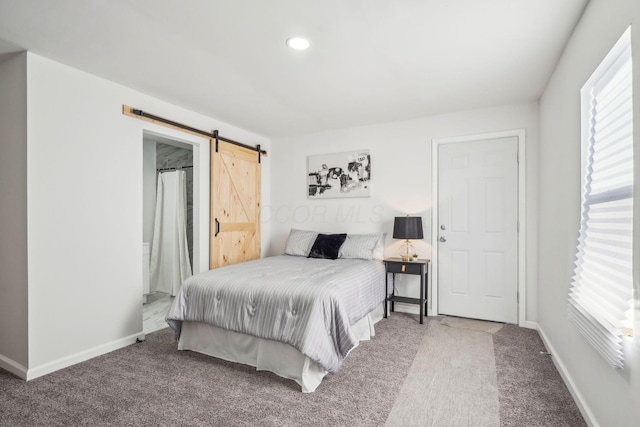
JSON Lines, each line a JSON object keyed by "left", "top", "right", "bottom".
{"left": 166, "top": 230, "right": 386, "bottom": 392}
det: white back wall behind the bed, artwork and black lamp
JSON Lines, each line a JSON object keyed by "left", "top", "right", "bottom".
{"left": 264, "top": 103, "right": 538, "bottom": 321}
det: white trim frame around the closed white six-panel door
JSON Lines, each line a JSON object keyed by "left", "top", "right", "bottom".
{"left": 428, "top": 129, "right": 527, "bottom": 327}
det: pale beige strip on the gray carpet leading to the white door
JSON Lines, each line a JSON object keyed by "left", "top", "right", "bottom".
{"left": 385, "top": 318, "right": 500, "bottom": 427}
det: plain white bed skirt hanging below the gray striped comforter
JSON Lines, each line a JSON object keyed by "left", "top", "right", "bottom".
{"left": 178, "top": 305, "right": 384, "bottom": 393}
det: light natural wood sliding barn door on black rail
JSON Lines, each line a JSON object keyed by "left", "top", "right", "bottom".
{"left": 209, "top": 140, "right": 260, "bottom": 268}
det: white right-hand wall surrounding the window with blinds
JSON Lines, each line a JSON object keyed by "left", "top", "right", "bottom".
{"left": 538, "top": 0, "right": 640, "bottom": 427}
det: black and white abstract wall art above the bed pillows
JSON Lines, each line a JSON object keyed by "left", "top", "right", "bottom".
{"left": 307, "top": 150, "right": 371, "bottom": 199}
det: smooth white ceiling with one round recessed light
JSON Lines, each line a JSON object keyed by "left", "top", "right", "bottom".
{"left": 0, "top": 0, "right": 588, "bottom": 137}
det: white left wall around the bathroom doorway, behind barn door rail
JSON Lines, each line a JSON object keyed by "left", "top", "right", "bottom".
{"left": 20, "top": 54, "right": 270, "bottom": 378}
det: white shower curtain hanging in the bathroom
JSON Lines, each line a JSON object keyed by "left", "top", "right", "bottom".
{"left": 149, "top": 171, "right": 191, "bottom": 295}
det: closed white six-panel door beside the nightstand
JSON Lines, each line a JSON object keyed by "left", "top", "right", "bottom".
{"left": 437, "top": 137, "right": 518, "bottom": 323}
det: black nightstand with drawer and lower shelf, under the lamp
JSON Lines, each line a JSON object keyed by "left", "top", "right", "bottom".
{"left": 384, "top": 258, "right": 429, "bottom": 324}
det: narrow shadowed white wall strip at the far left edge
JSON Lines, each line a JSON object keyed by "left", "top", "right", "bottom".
{"left": 0, "top": 54, "right": 28, "bottom": 375}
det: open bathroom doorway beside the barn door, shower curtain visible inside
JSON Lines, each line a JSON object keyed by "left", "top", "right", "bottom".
{"left": 142, "top": 131, "right": 209, "bottom": 334}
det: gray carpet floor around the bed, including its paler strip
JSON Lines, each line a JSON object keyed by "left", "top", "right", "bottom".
{"left": 0, "top": 313, "right": 584, "bottom": 426}
